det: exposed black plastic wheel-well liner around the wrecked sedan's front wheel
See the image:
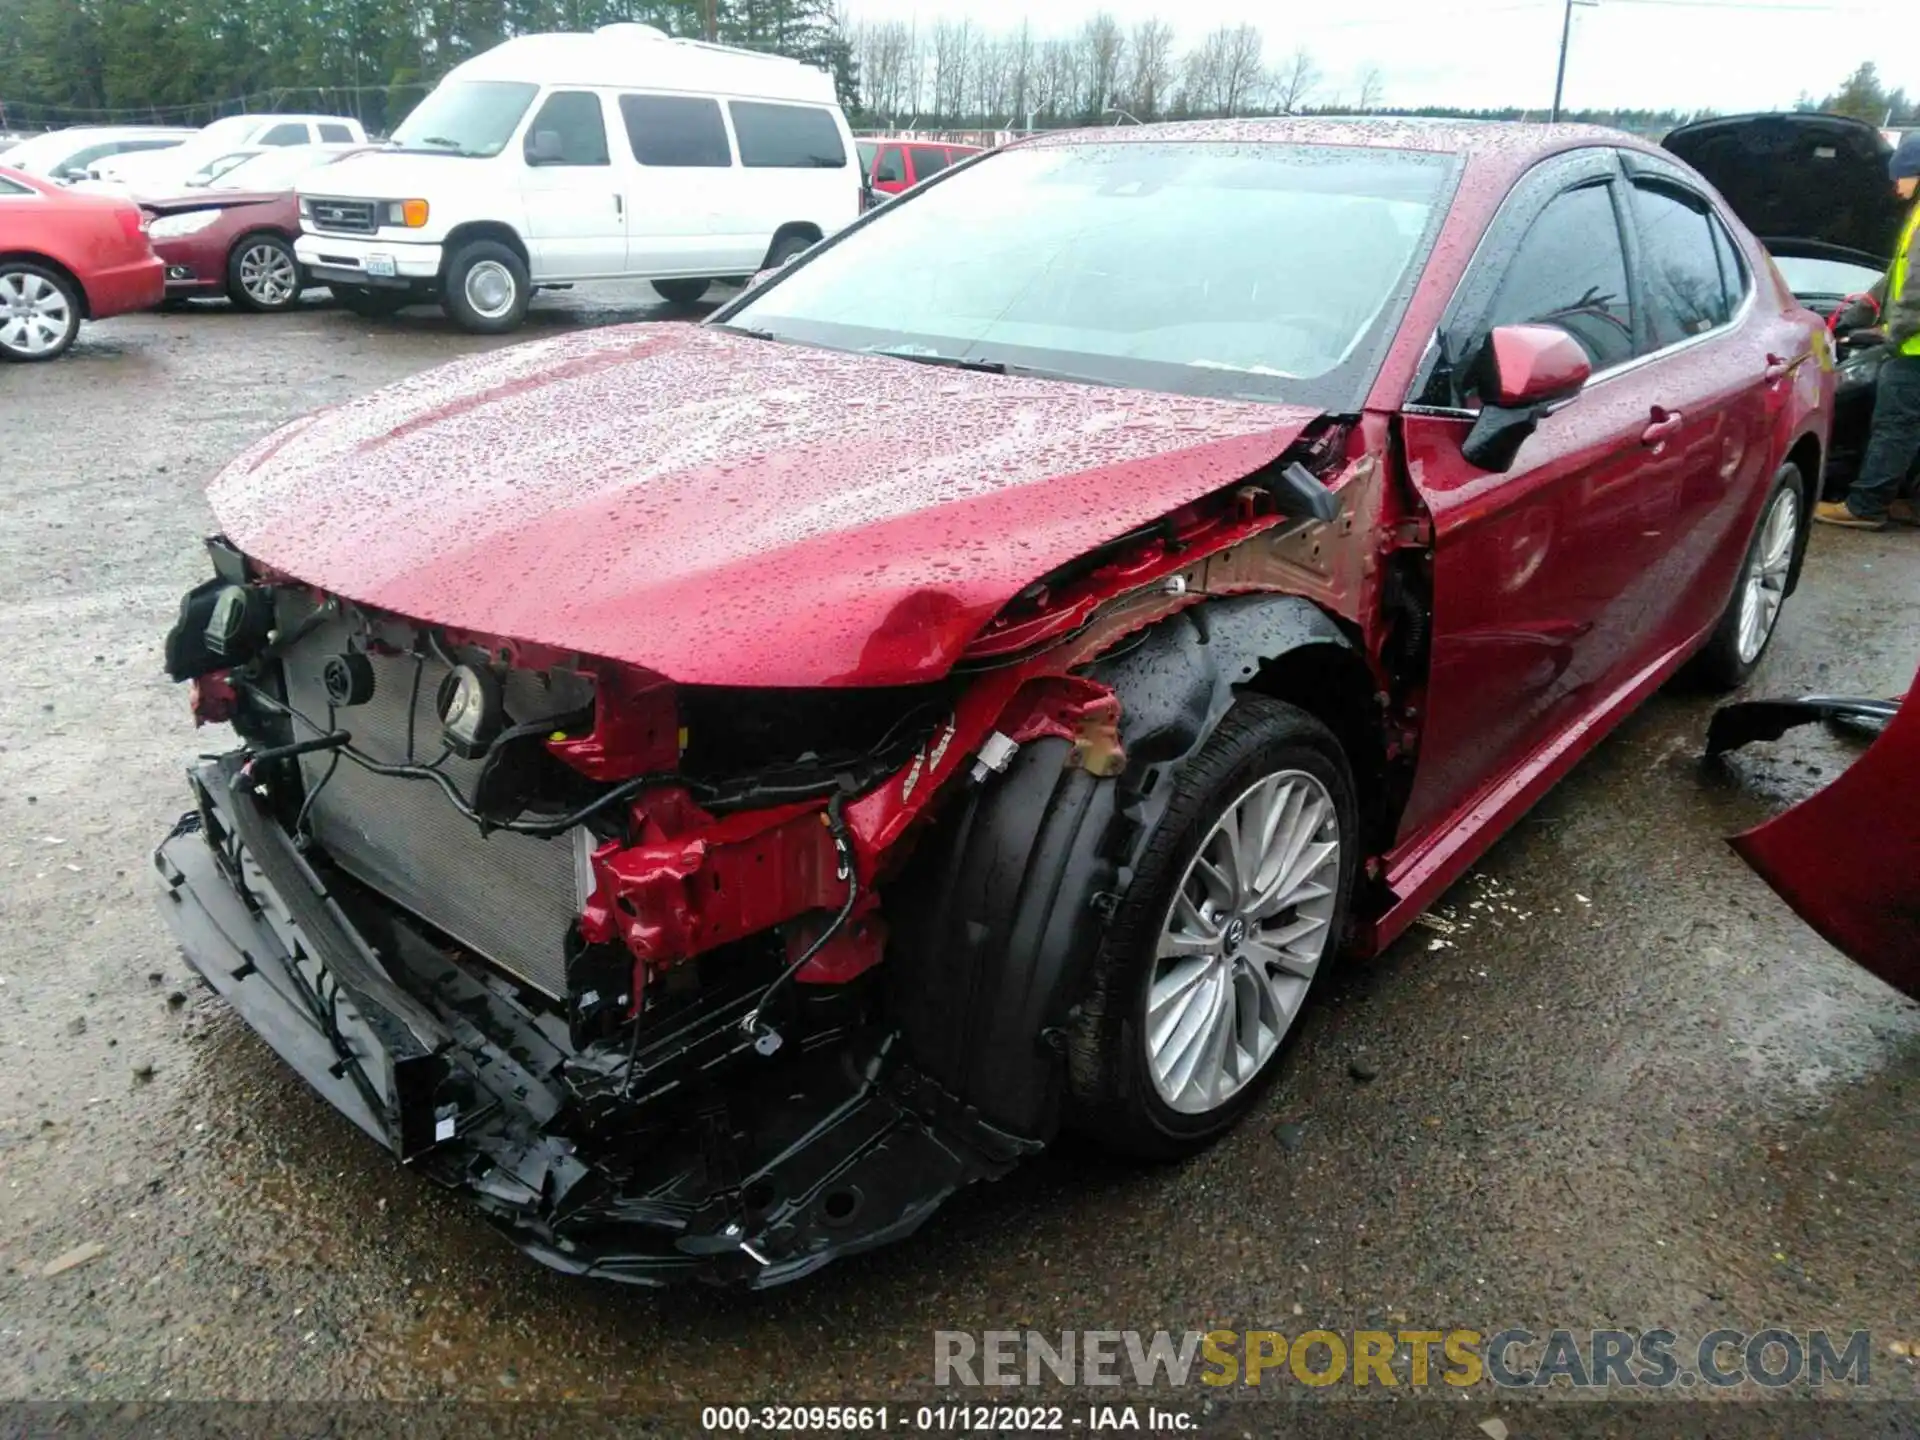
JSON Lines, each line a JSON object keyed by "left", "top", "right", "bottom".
{"left": 887, "top": 595, "right": 1350, "bottom": 1140}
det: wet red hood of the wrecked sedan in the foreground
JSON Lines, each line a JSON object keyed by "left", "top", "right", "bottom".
{"left": 209, "top": 324, "right": 1317, "bottom": 685}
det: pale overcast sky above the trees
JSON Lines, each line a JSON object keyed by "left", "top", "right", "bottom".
{"left": 845, "top": 0, "right": 1920, "bottom": 111}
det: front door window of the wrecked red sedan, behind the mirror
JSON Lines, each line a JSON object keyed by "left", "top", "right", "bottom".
{"left": 1488, "top": 184, "right": 1634, "bottom": 371}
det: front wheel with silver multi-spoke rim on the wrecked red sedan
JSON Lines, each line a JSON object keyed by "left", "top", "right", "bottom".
{"left": 1073, "top": 695, "right": 1361, "bottom": 1160}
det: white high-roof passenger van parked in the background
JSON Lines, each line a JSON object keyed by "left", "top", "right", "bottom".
{"left": 294, "top": 25, "right": 860, "bottom": 332}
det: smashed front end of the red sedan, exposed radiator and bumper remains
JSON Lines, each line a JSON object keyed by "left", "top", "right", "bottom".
{"left": 156, "top": 541, "right": 1037, "bottom": 1286}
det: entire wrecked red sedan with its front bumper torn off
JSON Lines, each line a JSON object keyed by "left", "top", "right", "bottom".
{"left": 157, "top": 121, "right": 1834, "bottom": 1284}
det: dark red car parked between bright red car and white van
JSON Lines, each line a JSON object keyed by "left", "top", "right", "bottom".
{"left": 140, "top": 146, "right": 362, "bottom": 311}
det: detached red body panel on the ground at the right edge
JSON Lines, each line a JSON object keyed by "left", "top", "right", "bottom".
{"left": 1730, "top": 660, "right": 1920, "bottom": 996}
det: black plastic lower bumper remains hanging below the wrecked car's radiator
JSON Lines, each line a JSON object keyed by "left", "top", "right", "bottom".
{"left": 154, "top": 756, "right": 1039, "bottom": 1288}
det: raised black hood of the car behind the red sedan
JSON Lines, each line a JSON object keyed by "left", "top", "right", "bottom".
{"left": 1663, "top": 113, "right": 1905, "bottom": 263}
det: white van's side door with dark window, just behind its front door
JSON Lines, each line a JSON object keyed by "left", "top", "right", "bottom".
{"left": 620, "top": 94, "right": 737, "bottom": 276}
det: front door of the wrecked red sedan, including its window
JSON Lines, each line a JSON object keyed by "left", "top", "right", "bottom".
{"left": 1402, "top": 150, "right": 1670, "bottom": 839}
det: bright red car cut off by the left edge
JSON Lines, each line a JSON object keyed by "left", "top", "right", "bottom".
{"left": 0, "top": 167, "right": 163, "bottom": 361}
